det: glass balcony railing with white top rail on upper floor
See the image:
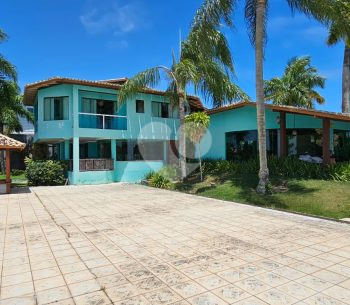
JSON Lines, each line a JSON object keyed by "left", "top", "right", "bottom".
{"left": 79, "top": 112, "right": 127, "bottom": 130}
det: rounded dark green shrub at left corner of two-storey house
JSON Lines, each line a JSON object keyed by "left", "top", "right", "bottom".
{"left": 25, "top": 158, "right": 65, "bottom": 186}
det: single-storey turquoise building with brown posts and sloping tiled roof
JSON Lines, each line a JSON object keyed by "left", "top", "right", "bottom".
{"left": 201, "top": 101, "right": 350, "bottom": 163}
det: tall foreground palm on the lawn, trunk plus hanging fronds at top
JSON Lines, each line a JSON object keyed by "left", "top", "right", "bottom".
{"left": 193, "top": 0, "right": 332, "bottom": 193}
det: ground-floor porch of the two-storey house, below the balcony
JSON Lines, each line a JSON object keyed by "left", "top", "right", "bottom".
{"left": 48, "top": 138, "right": 177, "bottom": 184}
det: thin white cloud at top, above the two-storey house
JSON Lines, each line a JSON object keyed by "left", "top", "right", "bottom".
{"left": 80, "top": 0, "right": 146, "bottom": 35}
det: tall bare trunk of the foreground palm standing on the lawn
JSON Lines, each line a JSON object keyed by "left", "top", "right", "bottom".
{"left": 255, "top": 0, "right": 269, "bottom": 194}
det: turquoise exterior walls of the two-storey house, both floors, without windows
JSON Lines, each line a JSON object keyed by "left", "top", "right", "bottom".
{"left": 34, "top": 85, "right": 179, "bottom": 184}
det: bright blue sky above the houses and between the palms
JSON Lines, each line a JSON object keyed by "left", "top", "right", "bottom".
{"left": 0, "top": 0, "right": 343, "bottom": 111}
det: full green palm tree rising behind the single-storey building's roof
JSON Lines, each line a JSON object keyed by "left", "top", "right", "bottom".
{"left": 265, "top": 56, "right": 325, "bottom": 109}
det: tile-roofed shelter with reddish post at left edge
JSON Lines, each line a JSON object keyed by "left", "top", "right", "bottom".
{"left": 0, "top": 134, "right": 26, "bottom": 194}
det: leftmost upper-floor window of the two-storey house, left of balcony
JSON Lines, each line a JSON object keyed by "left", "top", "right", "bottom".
{"left": 44, "top": 97, "right": 68, "bottom": 121}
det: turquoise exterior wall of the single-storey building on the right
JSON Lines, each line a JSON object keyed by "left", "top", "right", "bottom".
{"left": 201, "top": 105, "right": 350, "bottom": 159}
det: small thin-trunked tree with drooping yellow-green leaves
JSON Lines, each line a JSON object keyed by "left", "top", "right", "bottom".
{"left": 185, "top": 112, "right": 210, "bottom": 181}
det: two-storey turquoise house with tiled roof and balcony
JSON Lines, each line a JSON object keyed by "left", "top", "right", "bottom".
{"left": 24, "top": 77, "right": 204, "bottom": 184}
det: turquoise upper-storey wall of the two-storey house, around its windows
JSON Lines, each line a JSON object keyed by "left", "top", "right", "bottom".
{"left": 34, "top": 85, "right": 179, "bottom": 142}
